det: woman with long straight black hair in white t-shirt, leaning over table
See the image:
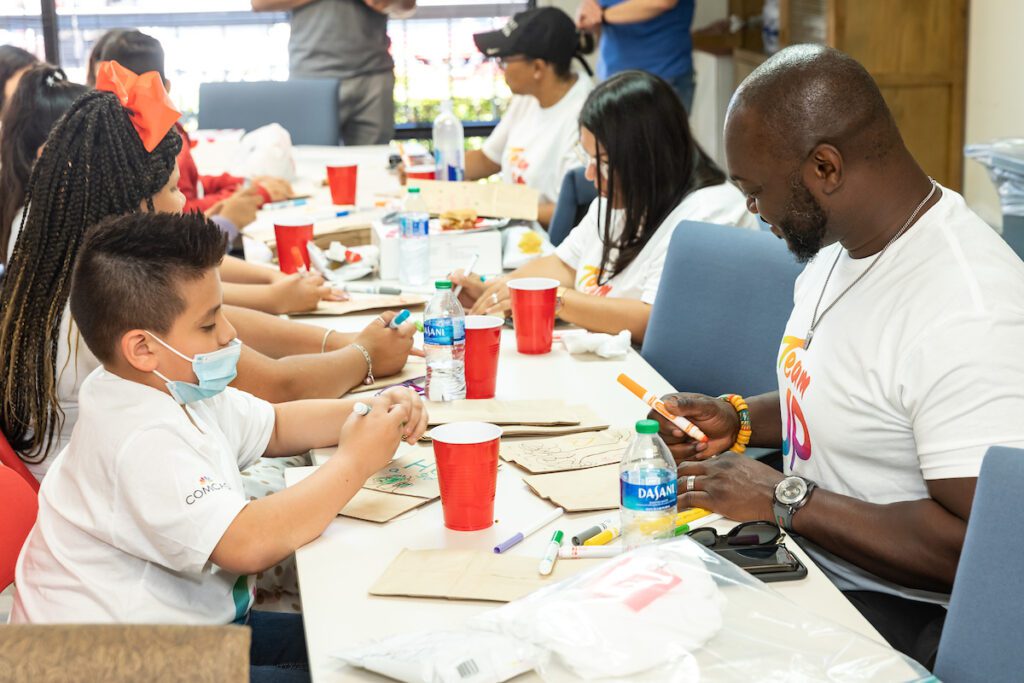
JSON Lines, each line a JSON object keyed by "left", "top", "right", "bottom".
{"left": 452, "top": 72, "right": 757, "bottom": 344}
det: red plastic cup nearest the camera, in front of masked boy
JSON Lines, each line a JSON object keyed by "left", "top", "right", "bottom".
{"left": 430, "top": 422, "right": 502, "bottom": 531}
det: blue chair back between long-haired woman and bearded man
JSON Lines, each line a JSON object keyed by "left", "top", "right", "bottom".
{"left": 641, "top": 221, "right": 801, "bottom": 396}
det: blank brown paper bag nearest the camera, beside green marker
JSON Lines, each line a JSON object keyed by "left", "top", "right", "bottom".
{"left": 370, "top": 549, "right": 600, "bottom": 602}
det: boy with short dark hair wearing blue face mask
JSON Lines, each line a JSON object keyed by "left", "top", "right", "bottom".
{"left": 11, "top": 213, "right": 426, "bottom": 679}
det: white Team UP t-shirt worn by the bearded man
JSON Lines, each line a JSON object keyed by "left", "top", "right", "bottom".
{"left": 777, "top": 188, "right": 1024, "bottom": 602}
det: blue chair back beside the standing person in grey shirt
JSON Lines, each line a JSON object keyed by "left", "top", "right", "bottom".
{"left": 199, "top": 79, "right": 341, "bottom": 146}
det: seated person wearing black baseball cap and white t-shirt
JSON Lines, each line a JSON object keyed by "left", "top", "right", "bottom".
{"left": 465, "top": 7, "right": 594, "bottom": 225}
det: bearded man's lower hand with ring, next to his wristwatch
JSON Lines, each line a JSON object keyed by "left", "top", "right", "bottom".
{"left": 676, "top": 450, "right": 783, "bottom": 522}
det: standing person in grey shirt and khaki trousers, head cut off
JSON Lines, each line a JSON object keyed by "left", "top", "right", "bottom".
{"left": 252, "top": 0, "right": 416, "bottom": 145}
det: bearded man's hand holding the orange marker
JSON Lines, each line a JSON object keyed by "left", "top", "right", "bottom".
{"left": 647, "top": 393, "right": 739, "bottom": 463}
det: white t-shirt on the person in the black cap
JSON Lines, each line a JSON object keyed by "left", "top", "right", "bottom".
{"left": 482, "top": 74, "right": 594, "bottom": 202}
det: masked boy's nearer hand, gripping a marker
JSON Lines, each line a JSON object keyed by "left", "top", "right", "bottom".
{"left": 338, "top": 396, "right": 409, "bottom": 478}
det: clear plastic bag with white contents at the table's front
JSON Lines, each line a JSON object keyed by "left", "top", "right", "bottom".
{"left": 333, "top": 539, "right": 934, "bottom": 683}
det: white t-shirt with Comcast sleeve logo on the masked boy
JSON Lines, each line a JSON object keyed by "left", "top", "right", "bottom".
{"left": 11, "top": 368, "right": 274, "bottom": 624}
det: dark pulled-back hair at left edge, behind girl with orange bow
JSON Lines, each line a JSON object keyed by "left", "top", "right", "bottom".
{"left": 0, "top": 65, "right": 89, "bottom": 265}
